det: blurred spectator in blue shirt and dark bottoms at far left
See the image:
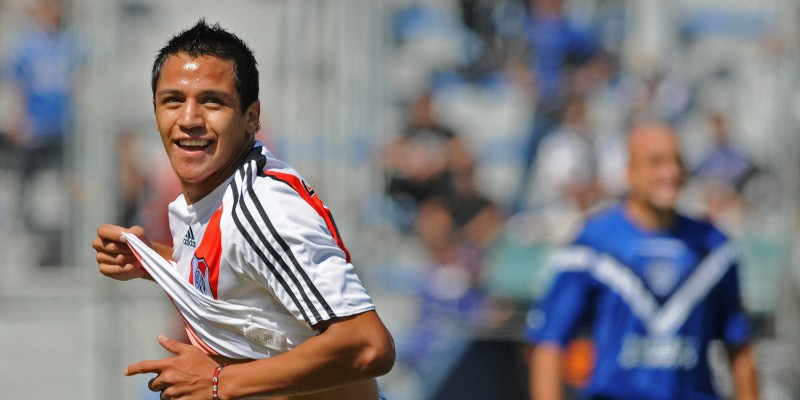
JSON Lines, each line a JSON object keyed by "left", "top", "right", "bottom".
{"left": 3, "top": 0, "right": 83, "bottom": 263}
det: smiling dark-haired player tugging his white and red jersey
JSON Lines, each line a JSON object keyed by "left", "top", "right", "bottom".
{"left": 93, "top": 20, "right": 394, "bottom": 400}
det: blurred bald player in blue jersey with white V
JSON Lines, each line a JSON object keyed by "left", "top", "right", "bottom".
{"left": 526, "top": 122, "right": 758, "bottom": 400}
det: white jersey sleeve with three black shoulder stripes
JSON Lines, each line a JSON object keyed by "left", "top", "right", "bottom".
{"left": 231, "top": 176, "right": 375, "bottom": 326}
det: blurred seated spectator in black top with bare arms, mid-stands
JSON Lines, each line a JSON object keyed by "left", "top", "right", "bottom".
{"left": 383, "top": 93, "right": 500, "bottom": 264}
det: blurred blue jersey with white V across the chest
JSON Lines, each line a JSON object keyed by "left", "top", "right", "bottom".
{"left": 525, "top": 205, "right": 751, "bottom": 400}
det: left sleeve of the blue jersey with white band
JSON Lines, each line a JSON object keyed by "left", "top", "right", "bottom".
{"left": 525, "top": 245, "right": 596, "bottom": 347}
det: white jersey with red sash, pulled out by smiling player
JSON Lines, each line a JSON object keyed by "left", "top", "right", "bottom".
{"left": 129, "top": 142, "right": 375, "bottom": 359}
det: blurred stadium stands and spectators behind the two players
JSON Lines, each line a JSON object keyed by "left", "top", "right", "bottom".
{"left": 0, "top": 0, "right": 800, "bottom": 400}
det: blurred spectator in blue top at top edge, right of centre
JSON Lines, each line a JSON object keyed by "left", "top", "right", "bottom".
{"left": 513, "top": 0, "right": 598, "bottom": 211}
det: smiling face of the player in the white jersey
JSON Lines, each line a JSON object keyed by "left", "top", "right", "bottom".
{"left": 153, "top": 53, "right": 260, "bottom": 204}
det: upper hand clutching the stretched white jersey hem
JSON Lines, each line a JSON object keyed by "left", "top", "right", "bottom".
{"left": 92, "top": 224, "right": 150, "bottom": 281}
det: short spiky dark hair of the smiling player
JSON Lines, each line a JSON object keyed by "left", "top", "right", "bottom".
{"left": 150, "top": 18, "right": 258, "bottom": 113}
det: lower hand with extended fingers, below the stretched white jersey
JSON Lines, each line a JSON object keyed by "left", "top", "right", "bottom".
{"left": 125, "top": 335, "right": 218, "bottom": 400}
